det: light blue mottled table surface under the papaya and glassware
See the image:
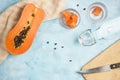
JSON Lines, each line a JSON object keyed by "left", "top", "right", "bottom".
{"left": 0, "top": 0, "right": 120, "bottom": 80}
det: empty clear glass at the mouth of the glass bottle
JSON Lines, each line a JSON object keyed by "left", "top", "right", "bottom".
{"left": 78, "top": 29, "right": 96, "bottom": 46}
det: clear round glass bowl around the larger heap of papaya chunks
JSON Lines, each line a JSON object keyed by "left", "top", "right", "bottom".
{"left": 60, "top": 8, "right": 80, "bottom": 29}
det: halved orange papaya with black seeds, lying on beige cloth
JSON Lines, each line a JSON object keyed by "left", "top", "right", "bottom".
{"left": 5, "top": 3, "right": 45, "bottom": 55}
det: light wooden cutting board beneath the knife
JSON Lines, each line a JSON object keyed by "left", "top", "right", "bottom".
{"left": 82, "top": 40, "right": 120, "bottom": 80}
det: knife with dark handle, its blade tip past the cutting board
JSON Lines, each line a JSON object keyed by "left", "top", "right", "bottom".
{"left": 77, "top": 63, "right": 120, "bottom": 74}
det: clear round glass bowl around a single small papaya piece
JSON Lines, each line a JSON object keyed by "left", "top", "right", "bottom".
{"left": 87, "top": 2, "right": 107, "bottom": 23}
